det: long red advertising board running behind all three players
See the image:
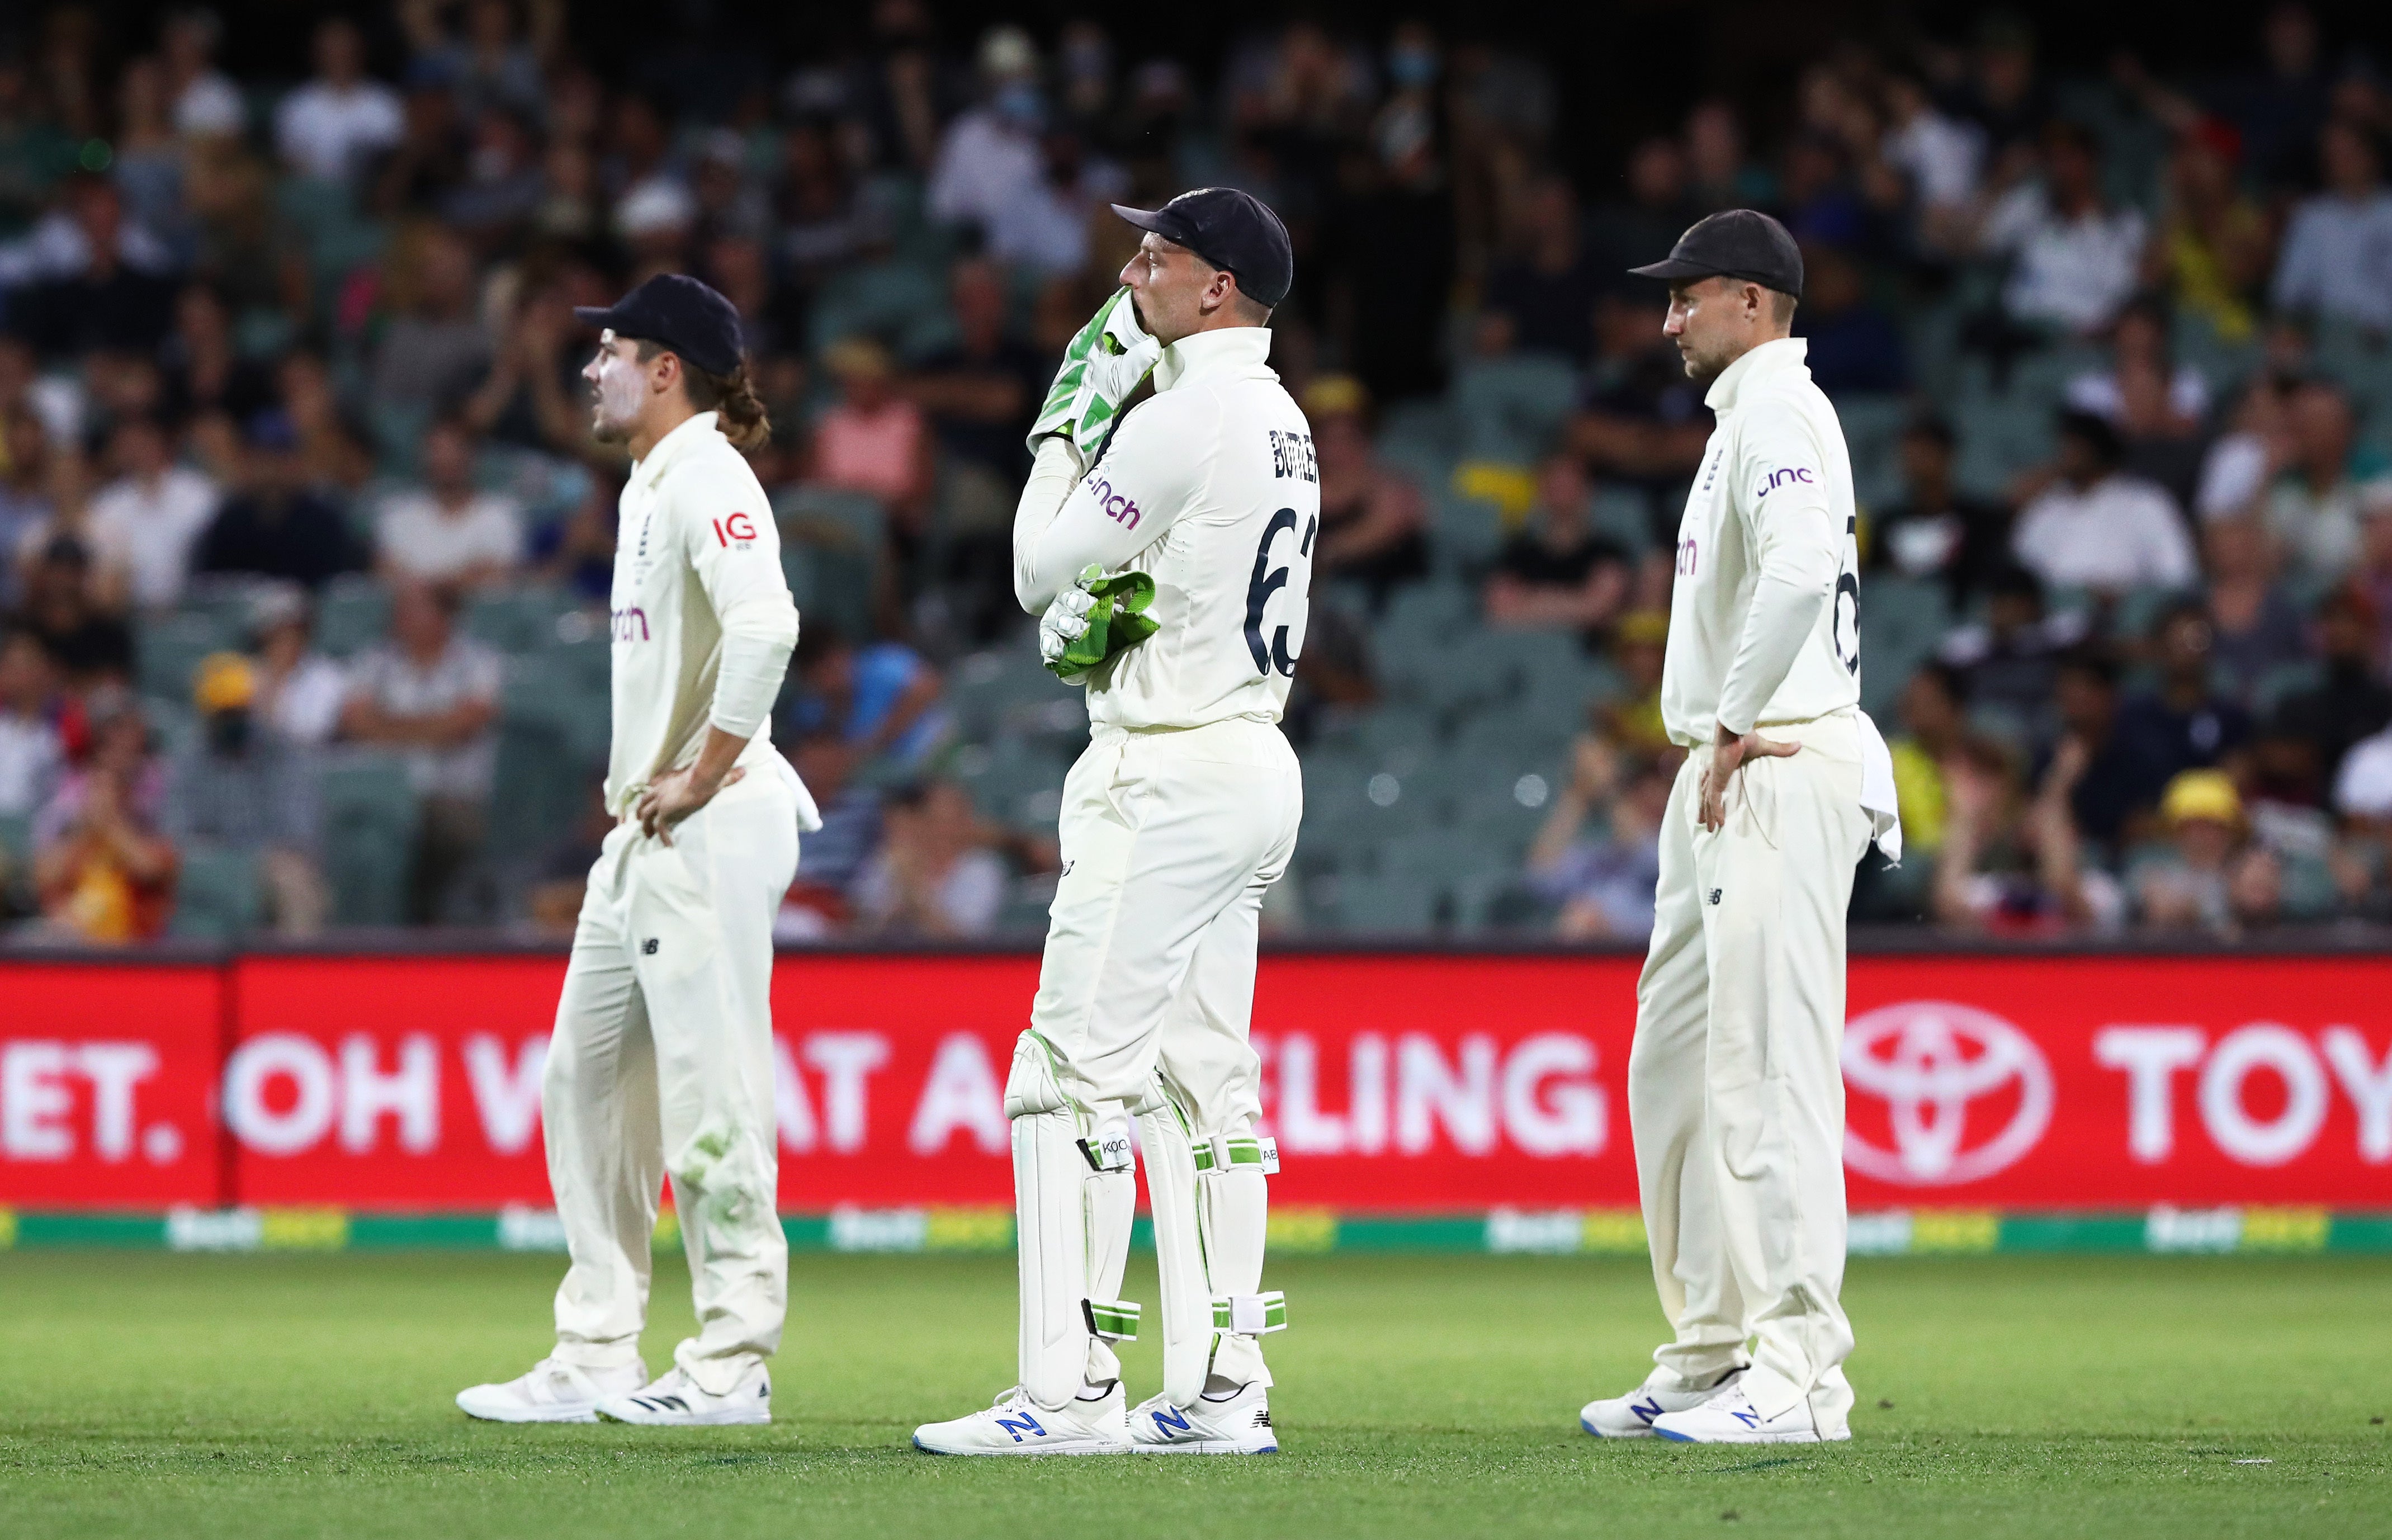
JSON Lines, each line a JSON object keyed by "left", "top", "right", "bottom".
{"left": 0, "top": 954, "right": 2392, "bottom": 1212}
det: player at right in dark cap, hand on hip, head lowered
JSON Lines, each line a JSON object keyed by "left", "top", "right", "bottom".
{"left": 1581, "top": 210, "right": 1899, "bottom": 1442}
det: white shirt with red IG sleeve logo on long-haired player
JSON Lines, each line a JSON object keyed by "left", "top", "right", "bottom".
{"left": 605, "top": 412, "right": 818, "bottom": 828}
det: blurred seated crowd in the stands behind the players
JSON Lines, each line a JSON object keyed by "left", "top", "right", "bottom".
{"left": 0, "top": 0, "right": 2392, "bottom": 942}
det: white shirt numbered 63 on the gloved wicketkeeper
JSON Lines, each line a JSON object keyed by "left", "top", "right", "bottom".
{"left": 1014, "top": 325, "right": 1320, "bottom": 729}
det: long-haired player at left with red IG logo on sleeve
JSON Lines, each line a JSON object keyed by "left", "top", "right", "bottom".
{"left": 457, "top": 275, "right": 820, "bottom": 1425}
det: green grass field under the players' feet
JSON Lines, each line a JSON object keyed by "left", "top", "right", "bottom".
{"left": 0, "top": 1253, "right": 2392, "bottom": 1540}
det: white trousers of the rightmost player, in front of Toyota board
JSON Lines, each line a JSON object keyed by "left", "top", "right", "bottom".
{"left": 1629, "top": 712, "right": 1868, "bottom": 1428}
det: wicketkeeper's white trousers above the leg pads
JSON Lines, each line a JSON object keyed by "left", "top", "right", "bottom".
{"left": 1031, "top": 717, "right": 1304, "bottom": 1141}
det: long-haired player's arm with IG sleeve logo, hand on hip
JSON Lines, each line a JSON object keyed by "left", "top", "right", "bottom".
{"left": 634, "top": 476, "right": 797, "bottom": 844}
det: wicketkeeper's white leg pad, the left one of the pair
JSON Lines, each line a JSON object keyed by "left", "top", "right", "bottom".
{"left": 1005, "top": 1033, "right": 1090, "bottom": 1411}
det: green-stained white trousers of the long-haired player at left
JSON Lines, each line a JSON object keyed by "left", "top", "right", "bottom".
{"left": 541, "top": 758, "right": 797, "bottom": 1394}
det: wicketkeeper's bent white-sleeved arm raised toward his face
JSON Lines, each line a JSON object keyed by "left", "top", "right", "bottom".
{"left": 1014, "top": 392, "right": 1220, "bottom": 615}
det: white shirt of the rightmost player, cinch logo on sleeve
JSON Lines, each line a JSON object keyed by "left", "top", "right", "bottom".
{"left": 1660, "top": 337, "right": 1861, "bottom": 749}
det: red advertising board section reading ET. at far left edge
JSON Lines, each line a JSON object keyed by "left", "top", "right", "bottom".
{"left": 0, "top": 963, "right": 225, "bottom": 1210}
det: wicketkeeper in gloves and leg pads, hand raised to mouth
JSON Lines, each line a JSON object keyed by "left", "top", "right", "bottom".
{"left": 914, "top": 189, "right": 1320, "bottom": 1454}
